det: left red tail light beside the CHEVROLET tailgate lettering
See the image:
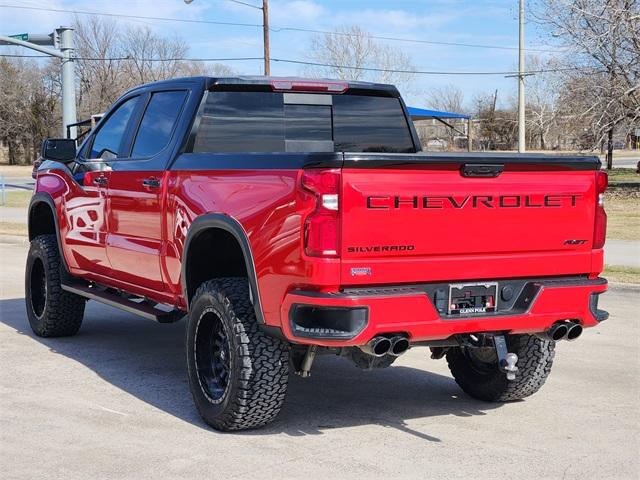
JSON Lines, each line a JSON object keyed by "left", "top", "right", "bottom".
{"left": 302, "top": 169, "right": 340, "bottom": 257}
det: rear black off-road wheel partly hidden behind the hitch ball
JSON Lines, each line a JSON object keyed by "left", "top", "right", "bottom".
{"left": 447, "top": 335, "right": 555, "bottom": 402}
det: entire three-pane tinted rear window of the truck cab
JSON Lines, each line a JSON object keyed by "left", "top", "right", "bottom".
{"left": 193, "top": 92, "right": 415, "bottom": 153}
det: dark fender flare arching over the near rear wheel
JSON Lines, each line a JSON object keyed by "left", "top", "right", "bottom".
{"left": 180, "top": 213, "right": 265, "bottom": 325}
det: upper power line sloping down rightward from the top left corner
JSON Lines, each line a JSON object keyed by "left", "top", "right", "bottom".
{"left": 0, "top": 0, "right": 559, "bottom": 53}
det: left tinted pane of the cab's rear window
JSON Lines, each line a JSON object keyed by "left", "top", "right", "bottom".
{"left": 193, "top": 92, "right": 285, "bottom": 152}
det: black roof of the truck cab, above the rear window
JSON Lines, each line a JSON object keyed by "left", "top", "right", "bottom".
{"left": 126, "top": 75, "right": 400, "bottom": 97}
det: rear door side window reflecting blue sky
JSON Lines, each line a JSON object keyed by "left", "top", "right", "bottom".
{"left": 131, "top": 90, "right": 187, "bottom": 157}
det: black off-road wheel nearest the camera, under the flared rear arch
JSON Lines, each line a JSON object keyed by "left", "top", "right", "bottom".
{"left": 187, "top": 278, "right": 289, "bottom": 431}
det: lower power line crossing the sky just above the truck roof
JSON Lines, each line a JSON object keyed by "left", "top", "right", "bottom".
{"left": 0, "top": 54, "right": 603, "bottom": 76}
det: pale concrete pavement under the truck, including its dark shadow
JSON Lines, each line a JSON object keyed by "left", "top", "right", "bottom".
{"left": 0, "top": 244, "right": 640, "bottom": 479}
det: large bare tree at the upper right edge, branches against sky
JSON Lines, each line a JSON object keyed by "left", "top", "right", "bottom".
{"left": 534, "top": 0, "right": 640, "bottom": 168}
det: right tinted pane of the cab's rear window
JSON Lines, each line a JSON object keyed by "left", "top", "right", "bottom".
{"left": 333, "top": 95, "right": 415, "bottom": 153}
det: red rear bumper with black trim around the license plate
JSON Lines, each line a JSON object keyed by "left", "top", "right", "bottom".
{"left": 280, "top": 277, "right": 608, "bottom": 346}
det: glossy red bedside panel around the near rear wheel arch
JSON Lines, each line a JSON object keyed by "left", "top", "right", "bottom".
{"left": 165, "top": 163, "right": 340, "bottom": 325}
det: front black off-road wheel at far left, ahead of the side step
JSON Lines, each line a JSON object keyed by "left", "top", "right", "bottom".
{"left": 25, "top": 235, "right": 86, "bottom": 337}
